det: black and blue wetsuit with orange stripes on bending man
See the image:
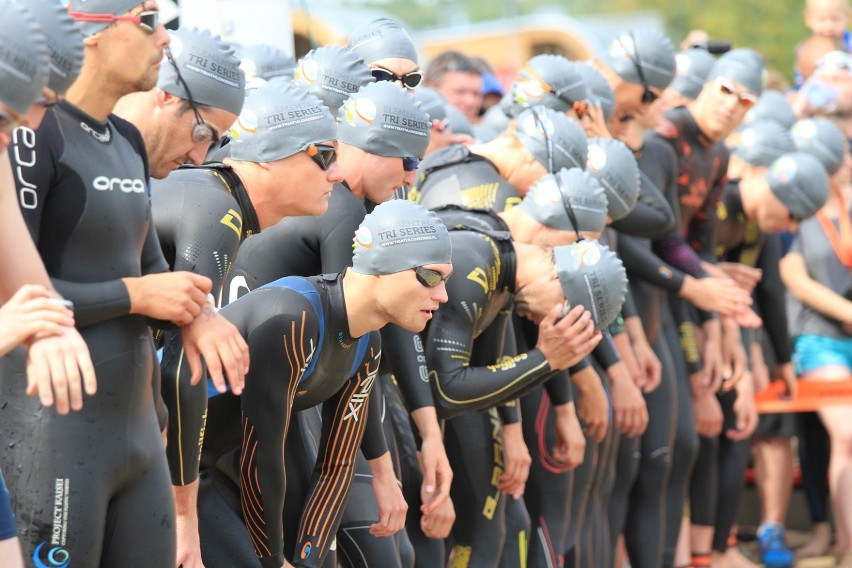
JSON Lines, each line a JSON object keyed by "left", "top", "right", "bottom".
{"left": 199, "top": 275, "right": 387, "bottom": 568}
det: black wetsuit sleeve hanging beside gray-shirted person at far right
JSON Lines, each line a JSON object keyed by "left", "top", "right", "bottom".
{"left": 754, "top": 235, "right": 793, "bottom": 364}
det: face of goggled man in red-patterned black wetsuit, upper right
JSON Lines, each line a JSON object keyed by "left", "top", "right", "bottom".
{"left": 689, "top": 77, "right": 757, "bottom": 141}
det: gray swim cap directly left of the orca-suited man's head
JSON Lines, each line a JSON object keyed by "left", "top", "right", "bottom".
{"left": 27, "top": 0, "right": 83, "bottom": 95}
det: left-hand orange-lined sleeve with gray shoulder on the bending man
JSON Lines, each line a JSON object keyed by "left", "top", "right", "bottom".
{"left": 231, "top": 288, "right": 322, "bottom": 568}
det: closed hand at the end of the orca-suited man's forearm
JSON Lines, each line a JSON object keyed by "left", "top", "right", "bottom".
{"left": 122, "top": 272, "right": 213, "bottom": 326}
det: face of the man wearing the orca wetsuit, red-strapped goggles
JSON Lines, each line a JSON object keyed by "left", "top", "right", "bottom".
{"left": 98, "top": 2, "right": 169, "bottom": 95}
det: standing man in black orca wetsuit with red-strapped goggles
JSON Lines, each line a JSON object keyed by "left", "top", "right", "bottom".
{"left": 0, "top": 0, "right": 247, "bottom": 566}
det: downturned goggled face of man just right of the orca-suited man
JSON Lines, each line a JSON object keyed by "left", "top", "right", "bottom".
{"left": 145, "top": 93, "right": 237, "bottom": 179}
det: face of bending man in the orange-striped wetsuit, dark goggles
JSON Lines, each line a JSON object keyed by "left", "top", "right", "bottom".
{"left": 376, "top": 264, "right": 453, "bottom": 332}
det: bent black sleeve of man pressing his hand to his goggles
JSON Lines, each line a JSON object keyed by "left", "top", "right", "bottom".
{"left": 425, "top": 277, "right": 551, "bottom": 418}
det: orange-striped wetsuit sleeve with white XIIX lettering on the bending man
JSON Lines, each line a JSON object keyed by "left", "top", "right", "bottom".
{"left": 296, "top": 332, "right": 381, "bottom": 568}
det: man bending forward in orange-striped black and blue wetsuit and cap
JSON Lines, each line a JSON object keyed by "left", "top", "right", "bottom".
{"left": 201, "top": 200, "right": 452, "bottom": 568}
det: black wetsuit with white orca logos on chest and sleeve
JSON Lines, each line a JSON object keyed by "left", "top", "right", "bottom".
{"left": 0, "top": 101, "right": 175, "bottom": 567}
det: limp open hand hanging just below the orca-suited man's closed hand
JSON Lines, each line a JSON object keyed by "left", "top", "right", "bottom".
{"left": 181, "top": 304, "right": 249, "bottom": 395}
